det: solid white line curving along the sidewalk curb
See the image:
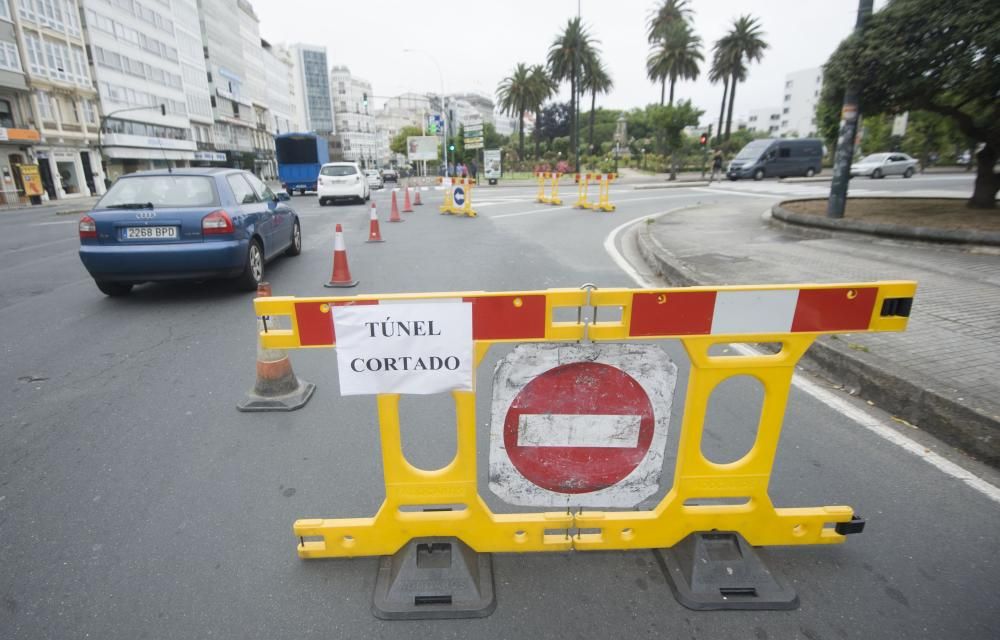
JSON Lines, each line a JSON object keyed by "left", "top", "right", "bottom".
{"left": 604, "top": 207, "right": 1000, "bottom": 504}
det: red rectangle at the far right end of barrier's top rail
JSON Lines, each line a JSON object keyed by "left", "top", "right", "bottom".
{"left": 792, "top": 287, "right": 878, "bottom": 331}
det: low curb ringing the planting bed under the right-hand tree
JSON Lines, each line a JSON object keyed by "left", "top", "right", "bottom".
{"left": 771, "top": 196, "right": 1000, "bottom": 246}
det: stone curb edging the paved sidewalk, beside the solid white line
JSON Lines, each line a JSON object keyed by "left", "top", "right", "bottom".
{"left": 636, "top": 216, "right": 1000, "bottom": 468}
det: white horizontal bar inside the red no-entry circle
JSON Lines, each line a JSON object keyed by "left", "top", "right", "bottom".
{"left": 517, "top": 413, "right": 642, "bottom": 449}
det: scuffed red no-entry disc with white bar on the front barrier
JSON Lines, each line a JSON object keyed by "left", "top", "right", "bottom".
{"left": 503, "top": 362, "right": 655, "bottom": 494}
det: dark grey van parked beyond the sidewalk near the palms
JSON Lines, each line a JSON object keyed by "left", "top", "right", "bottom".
{"left": 726, "top": 138, "right": 823, "bottom": 180}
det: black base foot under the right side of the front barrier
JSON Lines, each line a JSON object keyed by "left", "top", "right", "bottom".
{"left": 654, "top": 531, "right": 799, "bottom": 611}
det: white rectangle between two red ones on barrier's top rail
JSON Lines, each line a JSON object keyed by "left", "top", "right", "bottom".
{"left": 712, "top": 289, "right": 799, "bottom": 334}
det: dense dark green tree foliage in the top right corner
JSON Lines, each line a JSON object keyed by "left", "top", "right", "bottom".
{"left": 824, "top": 0, "right": 1000, "bottom": 209}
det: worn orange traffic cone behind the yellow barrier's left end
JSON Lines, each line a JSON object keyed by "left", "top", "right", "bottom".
{"left": 236, "top": 282, "right": 316, "bottom": 411}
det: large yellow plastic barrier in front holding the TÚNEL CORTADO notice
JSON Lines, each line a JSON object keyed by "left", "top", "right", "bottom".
{"left": 254, "top": 281, "right": 916, "bottom": 558}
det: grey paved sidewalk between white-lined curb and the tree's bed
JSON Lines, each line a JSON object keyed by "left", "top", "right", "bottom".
{"left": 637, "top": 201, "right": 1000, "bottom": 466}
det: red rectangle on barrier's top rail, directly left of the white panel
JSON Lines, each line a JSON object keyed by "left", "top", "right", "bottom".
{"left": 629, "top": 291, "right": 715, "bottom": 337}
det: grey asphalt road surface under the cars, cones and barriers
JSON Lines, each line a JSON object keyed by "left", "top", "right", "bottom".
{"left": 0, "top": 176, "right": 1000, "bottom": 640}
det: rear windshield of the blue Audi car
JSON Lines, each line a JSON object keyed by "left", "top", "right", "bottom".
{"left": 96, "top": 175, "right": 219, "bottom": 208}
